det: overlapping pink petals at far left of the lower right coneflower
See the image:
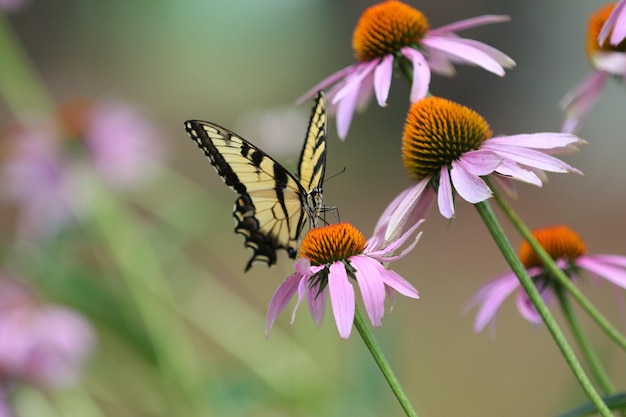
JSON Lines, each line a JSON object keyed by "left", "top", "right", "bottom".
{"left": 467, "top": 272, "right": 519, "bottom": 333}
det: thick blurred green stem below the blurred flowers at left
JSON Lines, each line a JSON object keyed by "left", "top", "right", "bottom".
{"left": 80, "top": 180, "right": 203, "bottom": 416}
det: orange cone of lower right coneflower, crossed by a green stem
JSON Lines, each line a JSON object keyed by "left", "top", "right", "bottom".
{"left": 518, "top": 225, "right": 587, "bottom": 268}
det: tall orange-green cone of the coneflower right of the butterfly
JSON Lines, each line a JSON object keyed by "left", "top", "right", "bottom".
{"left": 402, "top": 97, "right": 491, "bottom": 181}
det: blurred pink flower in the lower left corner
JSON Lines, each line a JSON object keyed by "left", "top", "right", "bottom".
{"left": 0, "top": 276, "right": 95, "bottom": 388}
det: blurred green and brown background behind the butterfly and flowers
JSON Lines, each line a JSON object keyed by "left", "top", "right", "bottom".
{"left": 0, "top": 0, "right": 626, "bottom": 417}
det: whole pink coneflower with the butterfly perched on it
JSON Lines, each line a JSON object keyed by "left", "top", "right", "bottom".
{"left": 265, "top": 223, "right": 421, "bottom": 339}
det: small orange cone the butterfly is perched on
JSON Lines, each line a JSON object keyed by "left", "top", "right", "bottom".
{"left": 300, "top": 223, "right": 367, "bottom": 265}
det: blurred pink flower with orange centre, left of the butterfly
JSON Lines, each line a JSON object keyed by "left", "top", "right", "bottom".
{"left": 2, "top": 101, "right": 164, "bottom": 236}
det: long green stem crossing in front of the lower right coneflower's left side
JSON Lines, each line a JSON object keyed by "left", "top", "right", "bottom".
{"left": 475, "top": 201, "right": 612, "bottom": 417}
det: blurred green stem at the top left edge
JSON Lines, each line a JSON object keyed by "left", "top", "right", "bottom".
{"left": 0, "top": 11, "right": 54, "bottom": 116}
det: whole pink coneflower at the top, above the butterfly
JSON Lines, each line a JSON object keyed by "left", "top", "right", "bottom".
{"left": 298, "top": 0, "right": 515, "bottom": 139}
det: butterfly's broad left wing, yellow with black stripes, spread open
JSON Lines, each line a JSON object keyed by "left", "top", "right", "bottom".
{"left": 185, "top": 120, "right": 307, "bottom": 271}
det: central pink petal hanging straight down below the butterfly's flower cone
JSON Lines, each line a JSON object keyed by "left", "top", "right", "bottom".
{"left": 328, "top": 262, "right": 354, "bottom": 339}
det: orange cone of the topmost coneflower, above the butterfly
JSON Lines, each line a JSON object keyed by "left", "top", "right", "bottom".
{"left": 352, "top": 0, "right": 429, "bottom": 62}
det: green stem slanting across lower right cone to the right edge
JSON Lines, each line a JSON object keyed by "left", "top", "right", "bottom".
{"left": 492, "top": 187, "right": 626, "bottom": 350}
